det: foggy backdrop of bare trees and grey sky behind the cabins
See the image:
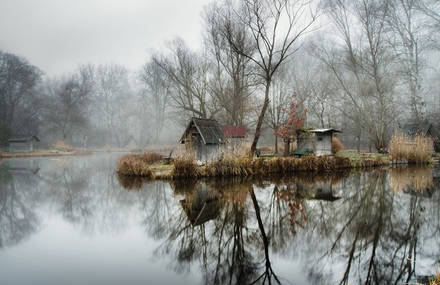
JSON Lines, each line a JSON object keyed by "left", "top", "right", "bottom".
{"left": 0, "top": 0, "right": 440, "bottom": 151}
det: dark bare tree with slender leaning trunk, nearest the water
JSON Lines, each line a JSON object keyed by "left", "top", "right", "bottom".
{"left": 222, "top": 0, "right": 317, "bottom": 154}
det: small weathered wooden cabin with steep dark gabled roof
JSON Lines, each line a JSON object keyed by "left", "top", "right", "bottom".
{"left": 180, "top": 118, "right": 225, "bottom": 161}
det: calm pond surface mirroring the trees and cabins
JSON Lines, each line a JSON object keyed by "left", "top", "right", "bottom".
{"left": 0, "top": 154, "right": 440, "bottom": 285}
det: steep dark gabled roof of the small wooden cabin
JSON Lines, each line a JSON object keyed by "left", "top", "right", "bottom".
{"left": 180, "top": 117, "right": 225, "bottom": 144}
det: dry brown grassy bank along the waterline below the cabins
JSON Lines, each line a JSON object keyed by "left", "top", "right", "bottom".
{"left": 116, "top": 153, "right": 390, "bottom": 180}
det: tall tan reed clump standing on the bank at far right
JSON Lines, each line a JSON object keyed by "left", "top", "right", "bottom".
{"left": 389, "top": 134, "right": 433, "bottom": 164}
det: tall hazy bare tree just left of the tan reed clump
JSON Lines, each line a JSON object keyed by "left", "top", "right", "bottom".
{"left": 316, "top": 0, "right": 395, "bottom": 151}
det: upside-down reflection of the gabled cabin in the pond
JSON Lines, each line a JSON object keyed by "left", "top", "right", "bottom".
{"left": 180, "top": 184, "right": 221, "bottom": 226}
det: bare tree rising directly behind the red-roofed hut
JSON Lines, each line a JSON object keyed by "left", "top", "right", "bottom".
{"left": 204, "top": 2, "right": 255, "bottom": 125}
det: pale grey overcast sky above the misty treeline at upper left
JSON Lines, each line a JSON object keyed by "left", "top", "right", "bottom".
{"left": 0, "top": 0, "right": 209, "bottom": 75}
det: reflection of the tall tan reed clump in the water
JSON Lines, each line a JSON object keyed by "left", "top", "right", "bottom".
{"left": 390, "top": 168, "right": 434, "bottom": 192}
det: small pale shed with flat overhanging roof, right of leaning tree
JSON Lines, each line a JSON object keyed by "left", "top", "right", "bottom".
{"left": 295, "top": 129, "right": 341, "bottom": 156}
